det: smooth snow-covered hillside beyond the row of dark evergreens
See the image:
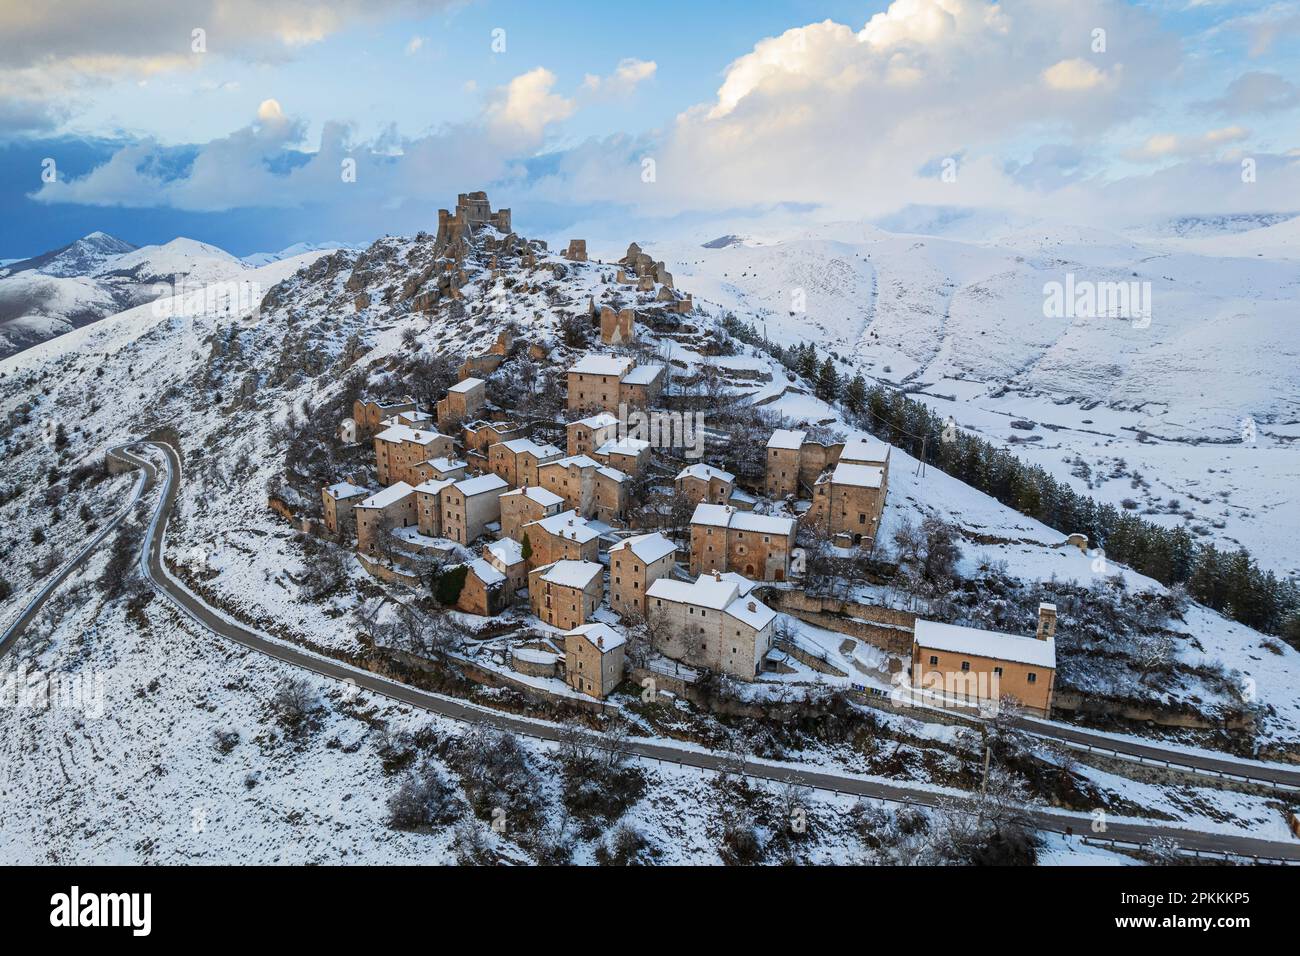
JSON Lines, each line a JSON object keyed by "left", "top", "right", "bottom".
{"left": 647, "top": 213, "right": 1300, "bottom": 574}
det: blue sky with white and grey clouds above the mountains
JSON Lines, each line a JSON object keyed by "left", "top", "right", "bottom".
{"left": 0, "top": 0, "right": 1300, "bottom": 258}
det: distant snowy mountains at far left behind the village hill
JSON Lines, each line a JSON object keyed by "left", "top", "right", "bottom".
{"left": 0, "top": 232, "right": 266, "bottom": 356}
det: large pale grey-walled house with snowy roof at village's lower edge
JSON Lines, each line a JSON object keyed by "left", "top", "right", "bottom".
{"left": 646, "top": 574, "right": 776, "bottom": 680}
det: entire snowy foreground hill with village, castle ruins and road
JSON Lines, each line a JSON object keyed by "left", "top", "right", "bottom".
{"left": 0, "top": 193, "right": 1300, "bottom": 864}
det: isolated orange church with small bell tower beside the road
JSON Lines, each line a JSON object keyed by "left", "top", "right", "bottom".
{"left": 911, "top": 604, "right": 1056, "bottom": 717}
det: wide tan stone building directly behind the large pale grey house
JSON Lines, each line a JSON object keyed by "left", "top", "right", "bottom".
{"left": 690, "top": 503, "right": 796, "bottom": 581}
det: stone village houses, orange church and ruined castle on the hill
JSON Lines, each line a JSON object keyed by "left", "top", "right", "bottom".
{"left": 312, "top": 193, "right": 1056, "bottom": 714}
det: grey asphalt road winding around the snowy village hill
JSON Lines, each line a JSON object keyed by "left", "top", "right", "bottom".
{"left": 0, "top": 441, "right": 1300, "bottom": 862}
